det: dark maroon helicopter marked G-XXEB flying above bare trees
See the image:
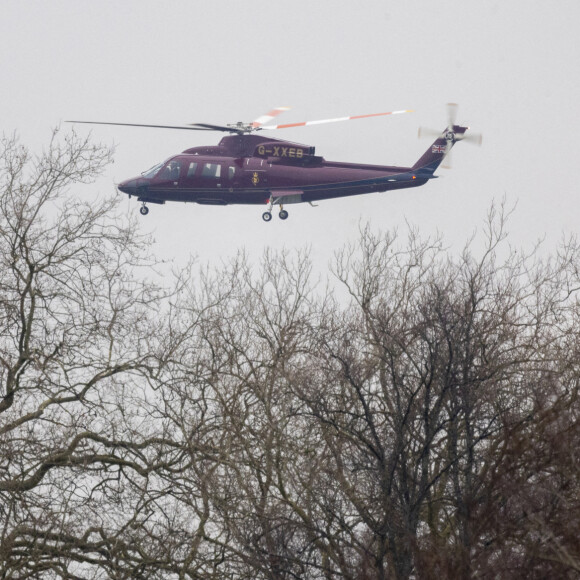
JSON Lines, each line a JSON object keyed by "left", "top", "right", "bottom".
{"left": 69, "top": 103, "right": 481, "bottom": 222}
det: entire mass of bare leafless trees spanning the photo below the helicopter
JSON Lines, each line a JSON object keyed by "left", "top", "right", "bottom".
{"left": 0, "top": 133, "right": 580, "bottom": 580}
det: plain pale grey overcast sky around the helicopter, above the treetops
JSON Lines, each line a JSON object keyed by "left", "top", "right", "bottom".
{"left": 0, "top": 0, "right": 580, "bottom": 265}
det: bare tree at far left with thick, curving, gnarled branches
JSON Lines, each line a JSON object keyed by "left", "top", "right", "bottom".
{"left": 0, "top": 132, "right": 181, "bottom": 577}
